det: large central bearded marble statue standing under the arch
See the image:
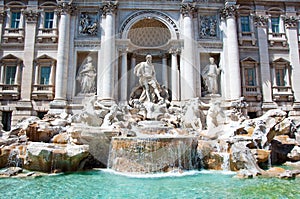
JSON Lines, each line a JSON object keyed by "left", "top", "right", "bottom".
{"left": 134, "top": 55, "right": 163, "bottom": 102}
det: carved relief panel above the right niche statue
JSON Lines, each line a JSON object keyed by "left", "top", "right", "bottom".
{"left": 199, "top": 16, "right": 217, "bottom": 38}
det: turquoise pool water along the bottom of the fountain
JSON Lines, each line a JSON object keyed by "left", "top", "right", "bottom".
{"left": 0, "top": 170, "right": 300, "bottom": 199}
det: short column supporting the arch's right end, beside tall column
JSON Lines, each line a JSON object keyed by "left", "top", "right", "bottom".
{"left": 170, "top": 49, "right": 180, "bottom": 101}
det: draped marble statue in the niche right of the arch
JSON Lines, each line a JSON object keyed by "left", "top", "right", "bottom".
{"left": 201, "top": 57, "right": 221, "bottom": 94}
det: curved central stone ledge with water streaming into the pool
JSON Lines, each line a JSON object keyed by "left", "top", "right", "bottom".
{"left": 108, "top": 137, "right": 197, "bottom": 173}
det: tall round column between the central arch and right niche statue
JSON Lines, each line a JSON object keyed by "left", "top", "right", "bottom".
{"left": 180, "top": 3, "right": 196, "bottom": 100}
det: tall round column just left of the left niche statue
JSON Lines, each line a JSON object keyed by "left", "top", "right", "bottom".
{"left": 51, "top": 2, "right": 73, "bottom": 108}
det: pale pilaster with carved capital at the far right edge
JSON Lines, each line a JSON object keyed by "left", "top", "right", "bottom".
{"left": 285, "top": 16, "right": 300, "bottom": 109}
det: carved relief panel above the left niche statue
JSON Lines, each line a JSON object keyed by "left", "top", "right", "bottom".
{"left": 79, "top": 13, "right": 98, "bottom": 35}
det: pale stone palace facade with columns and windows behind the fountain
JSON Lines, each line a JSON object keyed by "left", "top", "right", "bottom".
{"left": 0, "top": 0, "right": 300, "bottom": 130}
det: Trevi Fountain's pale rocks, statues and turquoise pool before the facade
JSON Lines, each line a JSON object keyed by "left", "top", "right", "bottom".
{"left": 0, "top": 55, "right": 300, "bottom": 198}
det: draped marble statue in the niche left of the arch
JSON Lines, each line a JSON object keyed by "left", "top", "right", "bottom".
{"left": 76, "top": 56, "right": 97, "bottom": 93}
